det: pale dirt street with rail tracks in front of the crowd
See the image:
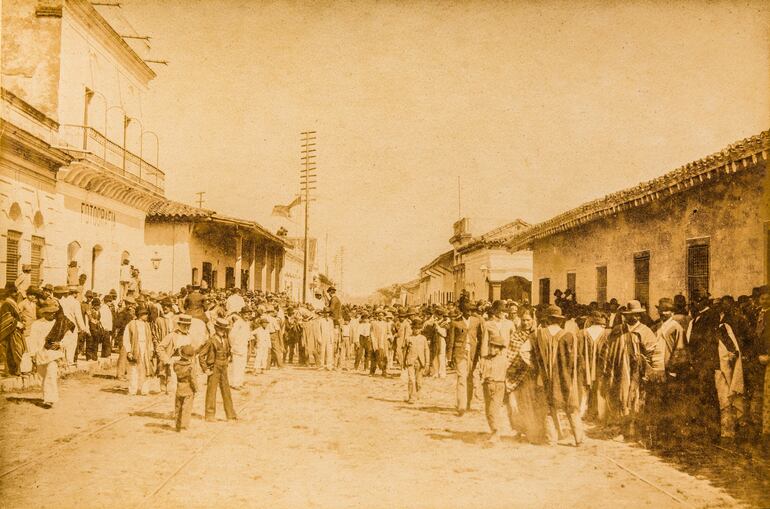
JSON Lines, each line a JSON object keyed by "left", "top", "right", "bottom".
{"left": 0, "top": 367, "right": 770, "bottom": 509}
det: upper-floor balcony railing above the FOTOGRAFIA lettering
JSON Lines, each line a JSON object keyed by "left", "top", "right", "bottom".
{"left": 59, "top": 124, "right": 166, "bottom": 194}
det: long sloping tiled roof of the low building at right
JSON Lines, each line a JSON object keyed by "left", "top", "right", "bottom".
{"left": 506, "top": 130, "right": 770, "bottom": 250}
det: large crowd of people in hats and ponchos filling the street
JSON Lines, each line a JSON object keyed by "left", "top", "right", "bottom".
{"left": 0, "top": 270, "right": 770, "bottom": 447}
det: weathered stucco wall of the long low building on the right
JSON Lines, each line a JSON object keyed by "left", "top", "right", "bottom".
{"left": 533, "top": 160, "right": 770, "bottom": 303}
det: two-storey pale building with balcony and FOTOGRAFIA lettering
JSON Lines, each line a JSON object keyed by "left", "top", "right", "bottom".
{"left": 0, "top": 0, "right": 165, "bottom": 292}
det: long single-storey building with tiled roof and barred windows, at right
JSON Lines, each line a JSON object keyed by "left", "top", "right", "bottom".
{"left": 508, "top": 131, "right": 770, "bottom": 310}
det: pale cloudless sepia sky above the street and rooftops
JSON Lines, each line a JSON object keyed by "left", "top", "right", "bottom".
{"left": 117, "top": 0, "right": 770, "bottom": 295}
